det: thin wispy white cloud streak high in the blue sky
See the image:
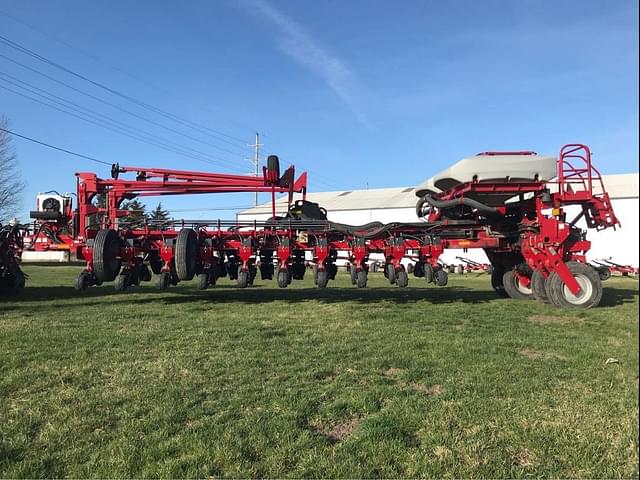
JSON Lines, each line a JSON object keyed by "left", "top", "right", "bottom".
{"left": 244, "top": 0, "right": 369, "bottom": 126}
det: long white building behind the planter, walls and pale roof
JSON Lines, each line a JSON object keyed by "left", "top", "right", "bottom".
{"left": 237, "top": 173, "right": 640, "bottom": 267}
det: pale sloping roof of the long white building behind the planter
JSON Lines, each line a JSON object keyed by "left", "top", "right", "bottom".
{"left": 238, "top": 173, "right": 638, "bottom": 215}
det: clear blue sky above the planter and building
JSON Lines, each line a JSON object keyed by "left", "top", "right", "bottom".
{"left": 0, "top": 0, "right": 638, "bottom": 218}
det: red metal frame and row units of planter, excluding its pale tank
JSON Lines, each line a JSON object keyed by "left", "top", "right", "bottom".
{"left": 26, "top": 144, "right": 619, "bottom": 308}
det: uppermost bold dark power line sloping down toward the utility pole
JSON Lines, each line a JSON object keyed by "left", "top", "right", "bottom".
{"left": 0, "top": 35, "right": 255, "bottom": 145}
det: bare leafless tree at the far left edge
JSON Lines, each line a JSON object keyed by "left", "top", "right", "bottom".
{"left": 0, "top": 117, "right": 24, "bottom": 221}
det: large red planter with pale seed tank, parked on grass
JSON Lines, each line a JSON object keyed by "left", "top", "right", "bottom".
{"left": 26, "top": 145, "right": 619, "bottom": 308}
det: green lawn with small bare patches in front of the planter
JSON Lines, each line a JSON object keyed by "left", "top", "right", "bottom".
{"left": 0, "top": 267, "right": 638, "bottom": 477}
